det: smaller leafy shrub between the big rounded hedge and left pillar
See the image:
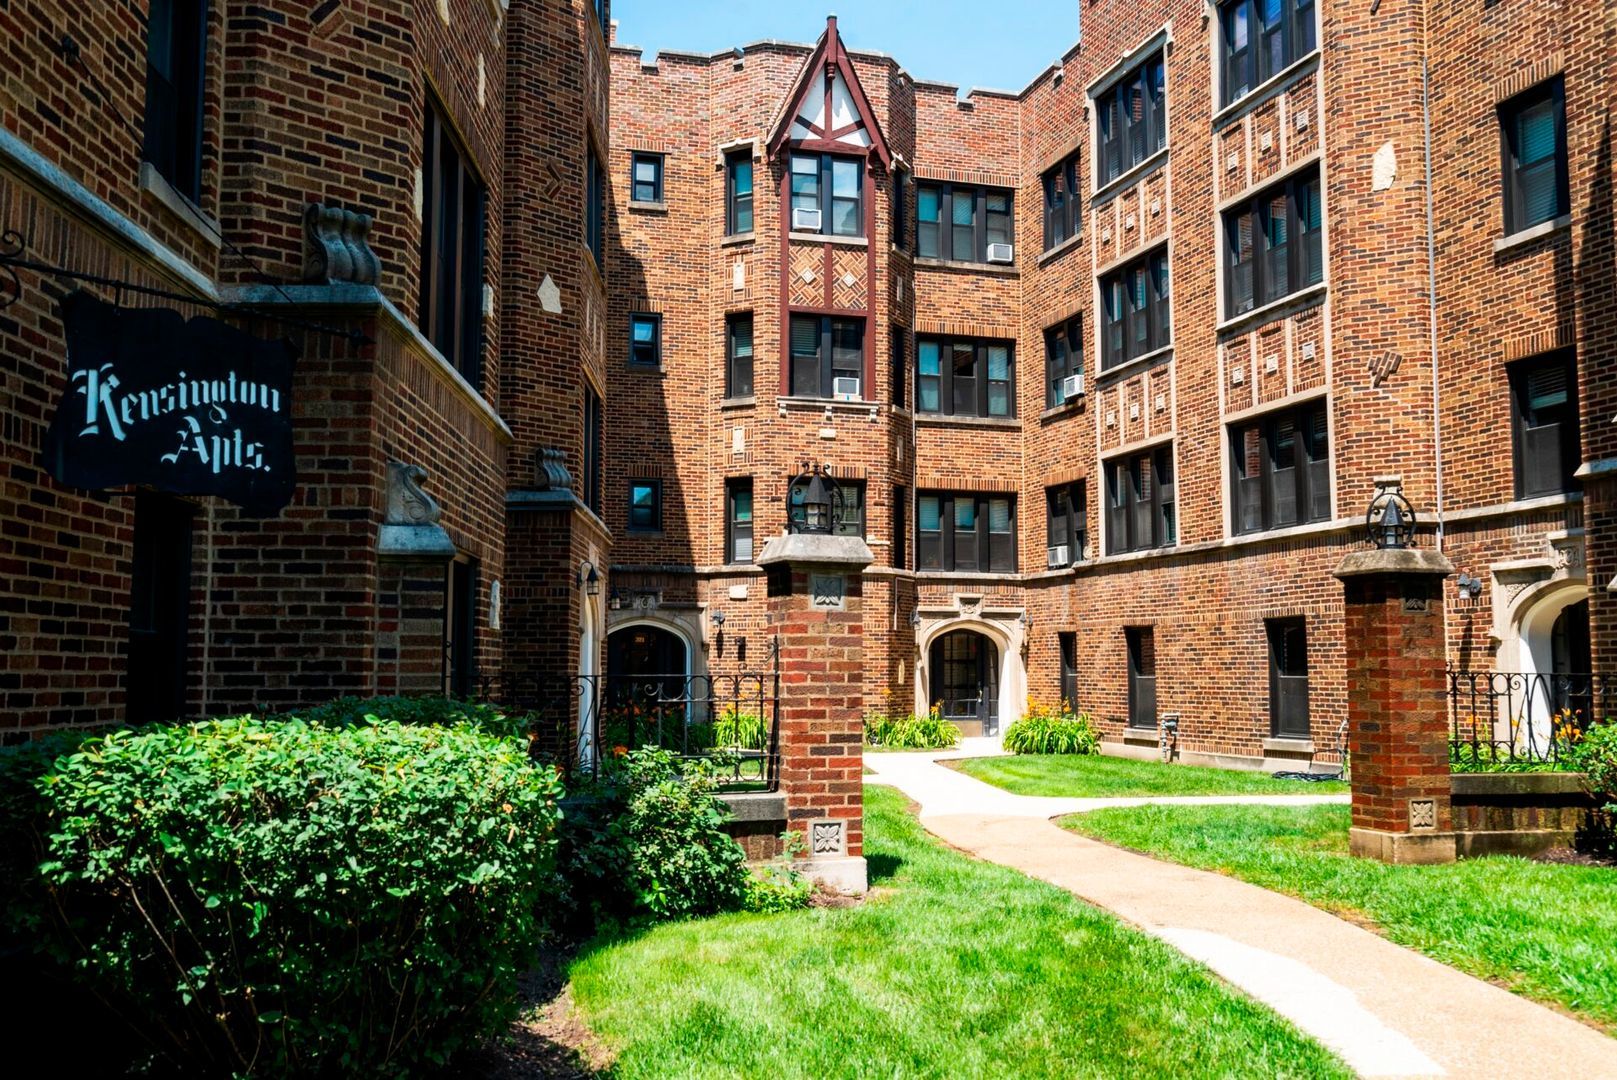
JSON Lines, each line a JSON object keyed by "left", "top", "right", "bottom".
{"left": 559, "top": 747, "right": 747, "bottom": 930}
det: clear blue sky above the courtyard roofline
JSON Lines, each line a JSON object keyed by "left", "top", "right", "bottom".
{"left": 611, "top": 0, "right": 1079, "bottom": 91}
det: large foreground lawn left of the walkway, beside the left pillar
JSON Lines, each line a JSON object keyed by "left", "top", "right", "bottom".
{"left": 569, "top": 786, "right": 1350, "bottom": 1080}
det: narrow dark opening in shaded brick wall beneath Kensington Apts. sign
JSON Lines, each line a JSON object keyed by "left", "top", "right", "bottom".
{"left": 126, "top": 491, "right": 196, "bottom": 724}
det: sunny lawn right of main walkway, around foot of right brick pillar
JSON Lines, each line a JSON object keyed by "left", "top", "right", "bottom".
{"left": 1062, "top": 807, "right": 1617, "bottom": 1034}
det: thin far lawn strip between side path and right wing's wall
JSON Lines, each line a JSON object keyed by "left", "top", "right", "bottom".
{"left": 951, "top": 753, "right": 1347, "bottom": 799}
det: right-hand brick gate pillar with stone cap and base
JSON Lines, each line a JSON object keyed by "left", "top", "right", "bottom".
{"left": 1336, "top": 548, "right": 1455, "bottom": 863}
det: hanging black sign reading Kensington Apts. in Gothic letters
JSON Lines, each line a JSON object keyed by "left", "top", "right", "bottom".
{"left": 45, "top": 293, "right": 296, "bottom": 516}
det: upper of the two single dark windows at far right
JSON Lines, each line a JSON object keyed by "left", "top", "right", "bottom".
{"left": 1499, "top": 76, "right": 1572, "bottom": 236}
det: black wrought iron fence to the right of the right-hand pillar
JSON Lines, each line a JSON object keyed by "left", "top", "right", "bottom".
{"left": 1449, "top": 668, "right": 1617, "bottom": 765}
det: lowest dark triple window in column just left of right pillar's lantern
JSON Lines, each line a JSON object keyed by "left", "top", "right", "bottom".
{"left": 1229, "top": 401, "right": 1331, "bottom": 534}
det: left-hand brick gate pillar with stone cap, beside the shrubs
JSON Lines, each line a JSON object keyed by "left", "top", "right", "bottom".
{"left": 758, "top": 535, "right": 872, "bottom": 892}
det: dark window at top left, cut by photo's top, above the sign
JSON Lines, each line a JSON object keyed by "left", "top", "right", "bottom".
{"left": 141, "top": 0, "right": 209, "bottom": 202}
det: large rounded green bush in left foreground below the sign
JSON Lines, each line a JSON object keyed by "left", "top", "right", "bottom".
{"left": 0, "top": 716, "right": 559, "bottom": 1075}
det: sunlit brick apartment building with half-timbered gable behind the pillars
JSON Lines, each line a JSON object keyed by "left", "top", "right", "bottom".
{"left": 603, "top": 0, "right": 1617, "bottom": 766}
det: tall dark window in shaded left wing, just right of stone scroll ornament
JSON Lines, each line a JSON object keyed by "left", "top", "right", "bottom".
{"left": 417, "top": 99, "right": 485, "bottom": 386}
